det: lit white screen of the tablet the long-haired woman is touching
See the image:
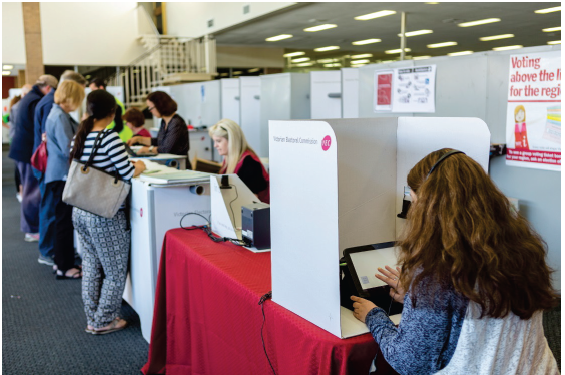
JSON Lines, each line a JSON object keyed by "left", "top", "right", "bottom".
{"left": 349, "top": 247, "right": 397, "bottom": 290}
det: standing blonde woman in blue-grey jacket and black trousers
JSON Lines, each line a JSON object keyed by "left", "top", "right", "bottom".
{"left": 45, "top": 81, "right": 84, "bottom": 280}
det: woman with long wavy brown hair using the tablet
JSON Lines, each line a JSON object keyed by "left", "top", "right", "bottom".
{"left": 351, "top": 149, "right": 559, "bottom": 375}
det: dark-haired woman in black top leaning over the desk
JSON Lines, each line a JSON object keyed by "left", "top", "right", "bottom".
{"left": 127, "top": 91, "right": 190, "bottom": 161}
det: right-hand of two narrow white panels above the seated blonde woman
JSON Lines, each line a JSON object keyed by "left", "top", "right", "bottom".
{"left": 239, "top": 76, "right": 261, "bottom": 155}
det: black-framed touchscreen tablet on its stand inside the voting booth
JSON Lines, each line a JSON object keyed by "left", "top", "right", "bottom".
{"left": 341, "top": 242, "right": 402, "bottom": 315}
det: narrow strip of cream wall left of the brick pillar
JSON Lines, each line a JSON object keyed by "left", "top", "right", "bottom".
{"left": 2, "top": 3, "right": 26, "bottom": 64}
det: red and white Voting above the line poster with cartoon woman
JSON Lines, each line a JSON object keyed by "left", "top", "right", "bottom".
{"left": 506, "top": 51, "right": 561, "bottom": 171}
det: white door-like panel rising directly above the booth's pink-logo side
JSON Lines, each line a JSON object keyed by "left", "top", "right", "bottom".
{"left": 310, "top": 70, "right": 342, "bottom": 119}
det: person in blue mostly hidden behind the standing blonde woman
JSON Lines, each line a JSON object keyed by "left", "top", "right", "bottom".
{"left": 32, "top": 70, "right": 87, "bottom": 266}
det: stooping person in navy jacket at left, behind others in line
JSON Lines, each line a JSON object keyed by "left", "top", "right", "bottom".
{"left": 8, "top": 74, "right": 58, "bottom": 242}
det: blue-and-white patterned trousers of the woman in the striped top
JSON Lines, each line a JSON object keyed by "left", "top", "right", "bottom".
{"left": 73, "top": 207, "right": 131, "bottom": 328}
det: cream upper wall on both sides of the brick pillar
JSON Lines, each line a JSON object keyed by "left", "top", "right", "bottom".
{"left": 2, "top": 2, "right": 144, "bottom": 66}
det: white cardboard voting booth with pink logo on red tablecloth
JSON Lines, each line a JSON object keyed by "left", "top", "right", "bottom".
{"left": 269, "top": 117, "right": 490, "bottom": 338}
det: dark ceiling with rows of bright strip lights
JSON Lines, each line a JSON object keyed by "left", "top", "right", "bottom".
{"left": 215, "top": 2, "right": 561, "bottom": 62}
